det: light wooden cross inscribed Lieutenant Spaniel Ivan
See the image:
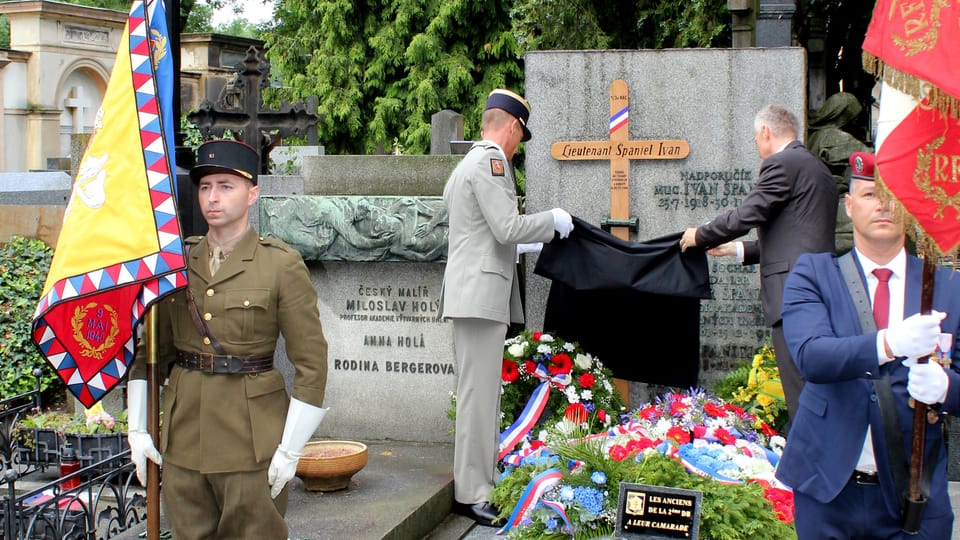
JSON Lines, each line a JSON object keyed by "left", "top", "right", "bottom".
{"left": 550, "top": 79, "right": 690, "bottom": 240}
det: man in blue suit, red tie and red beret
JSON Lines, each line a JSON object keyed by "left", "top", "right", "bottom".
{"left": 777, "top": 152, "right": 960, "bottom": 540}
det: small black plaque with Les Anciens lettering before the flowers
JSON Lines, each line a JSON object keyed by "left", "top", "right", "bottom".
{"left": 615, "top": 482, "right": 703, "bottom": 540}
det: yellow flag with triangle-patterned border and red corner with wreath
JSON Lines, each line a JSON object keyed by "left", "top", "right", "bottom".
{"left": 33, "top": 0, "right": 187, "bottom": 407}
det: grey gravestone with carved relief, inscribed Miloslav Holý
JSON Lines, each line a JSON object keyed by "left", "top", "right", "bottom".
{"left": 257, "top": 156, "right": 460, "bottom": 442}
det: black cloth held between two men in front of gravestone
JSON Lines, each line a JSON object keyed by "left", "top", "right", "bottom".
{"left": 534, "top": 217, "right": 712, "bottom": 387}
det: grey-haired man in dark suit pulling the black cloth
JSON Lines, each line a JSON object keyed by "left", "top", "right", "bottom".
{"left": 680, "top": 105, "right": 837, "bottom": 418}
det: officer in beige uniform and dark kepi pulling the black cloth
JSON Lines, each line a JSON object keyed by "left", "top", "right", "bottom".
{"left": 440, "top": 89, "right": 573, "bottom": 526}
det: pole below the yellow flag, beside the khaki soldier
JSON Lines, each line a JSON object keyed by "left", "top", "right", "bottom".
{"left": 144, "top": 306, "right": 160, "bottom": 540}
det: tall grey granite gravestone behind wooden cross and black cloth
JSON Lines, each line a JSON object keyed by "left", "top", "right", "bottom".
{"left": 525, "top": 48, "right": 806, "bottom": 394}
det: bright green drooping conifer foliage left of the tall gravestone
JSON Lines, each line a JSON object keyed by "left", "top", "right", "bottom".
{"left": 264, "top": 0, "right": 523, "bottom": 154}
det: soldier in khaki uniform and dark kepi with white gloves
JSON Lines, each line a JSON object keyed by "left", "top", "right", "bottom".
{"left": 128, "top": 140, "right": 327, "bottom": 540}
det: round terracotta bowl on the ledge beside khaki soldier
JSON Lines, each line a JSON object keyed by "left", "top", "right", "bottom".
{"left": 297, "top": 441, "right": 367, "bottom": 491}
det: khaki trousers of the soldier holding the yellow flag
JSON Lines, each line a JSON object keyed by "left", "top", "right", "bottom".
{"left": 161, "top": 462, "right": 290, "bottom": 540}
